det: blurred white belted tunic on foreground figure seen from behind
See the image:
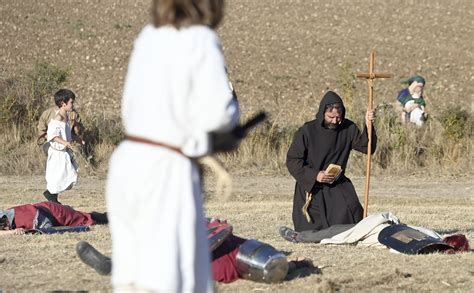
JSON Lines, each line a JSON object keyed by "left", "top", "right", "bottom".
{"left": 107, "top": 25, "right": 239, "bottom": 292}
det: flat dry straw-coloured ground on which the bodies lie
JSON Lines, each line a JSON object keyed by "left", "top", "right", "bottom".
{"left": 0, "top": 175, "right": 474, "bottom": 292}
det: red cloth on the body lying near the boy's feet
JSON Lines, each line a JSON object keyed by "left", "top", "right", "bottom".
{"left": 13, "top": 201, "right": 95, "bottom": 229}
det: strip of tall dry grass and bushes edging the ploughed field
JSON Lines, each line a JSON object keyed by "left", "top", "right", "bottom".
{"left": 0, "top": 63, "right": 473, "bottom": 176}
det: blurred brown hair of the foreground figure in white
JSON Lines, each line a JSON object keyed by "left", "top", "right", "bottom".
{"left": 151, "top": 0, "right": 224, "bottom": 29}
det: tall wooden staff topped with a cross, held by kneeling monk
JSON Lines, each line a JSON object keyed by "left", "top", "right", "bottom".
{"left": 357, "top": 52, "right": 392, "bottom": 218}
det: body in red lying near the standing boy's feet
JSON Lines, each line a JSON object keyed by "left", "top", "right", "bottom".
{"left": 0, "top": 202, "right": 108, "bottom": 235}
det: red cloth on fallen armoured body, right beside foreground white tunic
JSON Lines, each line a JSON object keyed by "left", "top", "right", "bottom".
{"left": 212, "top": 235, "right": 247, "bottom": 283}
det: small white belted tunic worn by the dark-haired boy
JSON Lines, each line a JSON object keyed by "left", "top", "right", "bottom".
{"left": 45, "top": 119, "right": 78, "bottom": 193}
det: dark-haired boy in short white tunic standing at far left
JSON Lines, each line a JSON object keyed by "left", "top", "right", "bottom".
{"left": 43, "top": 89, "right": 79, "bottom": 203}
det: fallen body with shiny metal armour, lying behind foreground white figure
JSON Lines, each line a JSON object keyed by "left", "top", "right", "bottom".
{"left": 76, "top": 219, "right": 314, "bottom": 283}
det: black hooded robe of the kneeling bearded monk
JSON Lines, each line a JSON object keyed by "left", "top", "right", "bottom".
{"left": 286, "top": 91, "right": 377, "bottom": 232}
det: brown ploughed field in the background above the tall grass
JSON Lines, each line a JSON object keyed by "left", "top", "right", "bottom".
{"left": 0, "top": 0, "right": 474, "bottom": 124}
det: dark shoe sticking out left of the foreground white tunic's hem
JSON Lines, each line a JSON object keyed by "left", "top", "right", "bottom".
{"left": 76, "top": 241, "right": 112, "bottom": 276}
